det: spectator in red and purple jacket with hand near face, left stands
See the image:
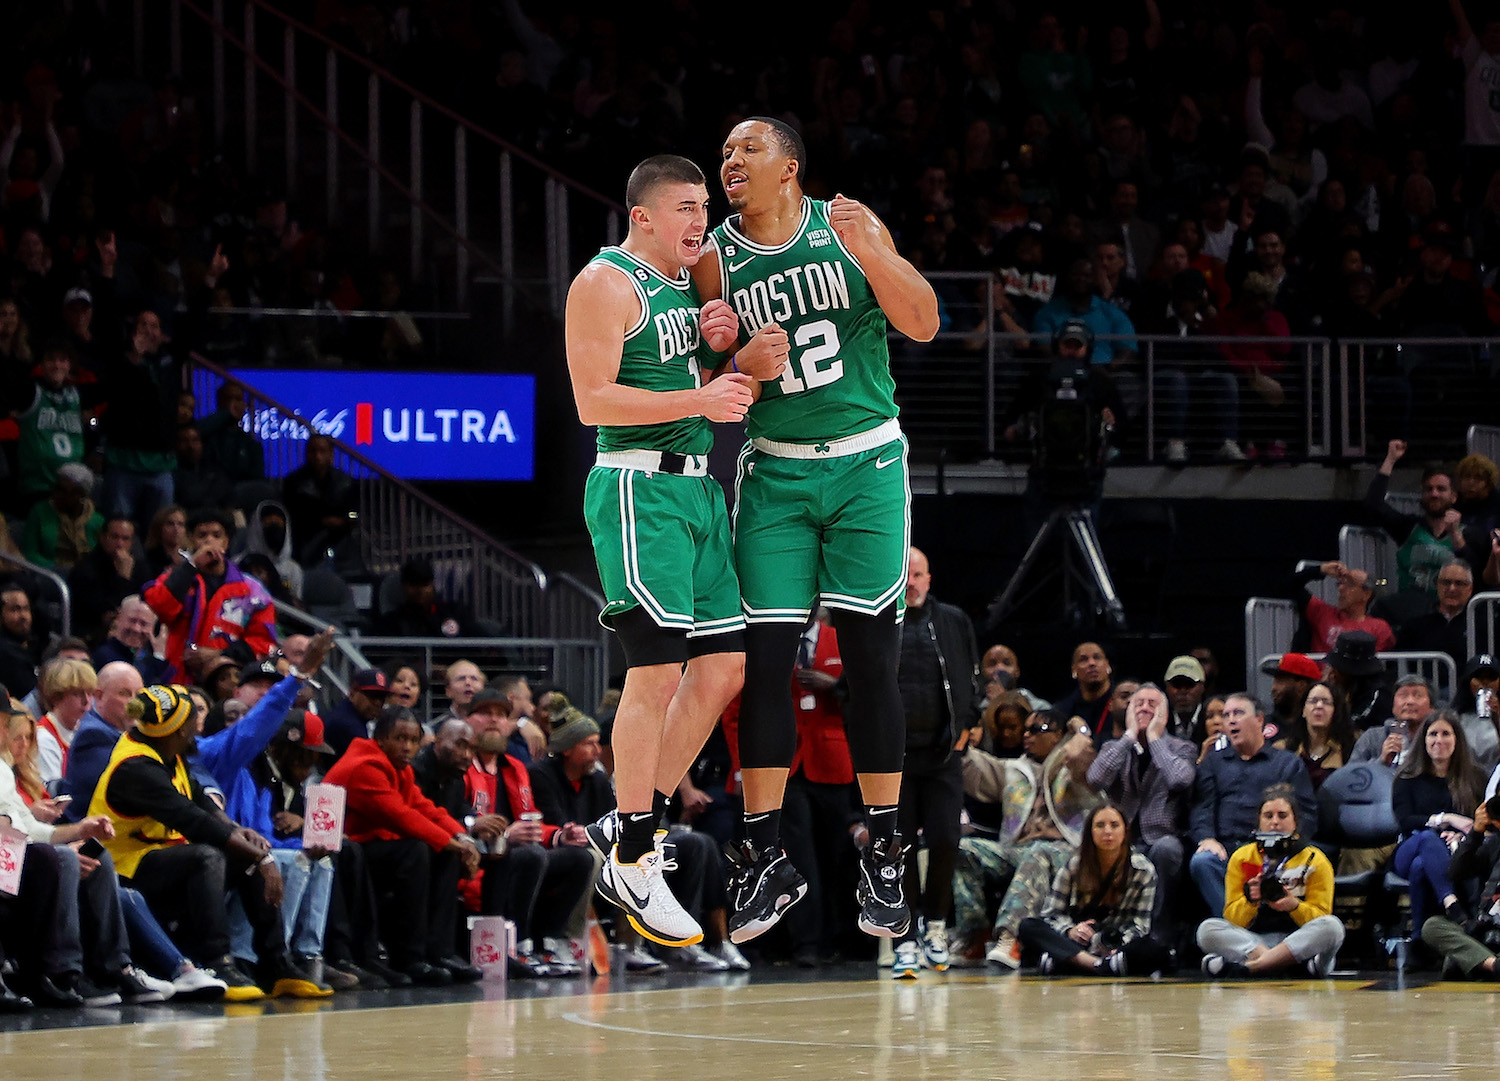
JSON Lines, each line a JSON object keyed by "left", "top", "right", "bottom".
{"left": 143, "top": 510, "right": 276, "bottom": 682}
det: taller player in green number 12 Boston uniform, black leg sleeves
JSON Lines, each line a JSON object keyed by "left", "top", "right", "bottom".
{"left": 693, "top": 117, "right": 938, "bottom": 942}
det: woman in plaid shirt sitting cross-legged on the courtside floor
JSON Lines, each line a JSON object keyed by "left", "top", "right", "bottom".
{"left": 1020, "top": 804, "right": 1176, "bottom": 976}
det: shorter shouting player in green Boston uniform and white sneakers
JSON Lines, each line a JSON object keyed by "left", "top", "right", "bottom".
{"left": 566, "top": 154, "right": 786, "bottom": 946}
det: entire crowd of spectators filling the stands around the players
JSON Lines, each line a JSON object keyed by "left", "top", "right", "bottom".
{"left": 0, "top": 0, "right": 1500, "bottom": 1008}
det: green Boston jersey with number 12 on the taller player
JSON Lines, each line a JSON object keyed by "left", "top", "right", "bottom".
{"left": 713, "top": 196, "right": 896, "bottom": 442}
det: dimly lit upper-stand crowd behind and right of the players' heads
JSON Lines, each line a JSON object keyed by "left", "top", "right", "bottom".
{"left": 304, "top": 0, "right": 1500, "bottom": 462}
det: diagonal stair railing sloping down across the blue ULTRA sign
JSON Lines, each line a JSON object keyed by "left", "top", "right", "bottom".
{"left": 188, "top": 355, "right": 608, "bottom": 665}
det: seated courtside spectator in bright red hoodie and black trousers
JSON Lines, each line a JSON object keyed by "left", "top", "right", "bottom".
{"left": 324, "top": 706, "right": 480, "bottom": 987}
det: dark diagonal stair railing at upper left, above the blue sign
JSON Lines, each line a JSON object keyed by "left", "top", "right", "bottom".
{"left": 138, "top": 0, "right": 626, "bottom": 322}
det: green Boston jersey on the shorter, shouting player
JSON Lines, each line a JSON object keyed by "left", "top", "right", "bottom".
{"left": 594, "top": 247, "right": 714, "bottom": 454}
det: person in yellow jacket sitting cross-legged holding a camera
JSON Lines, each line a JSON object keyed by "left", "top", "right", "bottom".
{"left": 1199, "top": 784, "right": 1344, "bottom": 978}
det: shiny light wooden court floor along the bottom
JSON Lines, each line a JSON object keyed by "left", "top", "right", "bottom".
{"left": 0, "top": 969, "right": 1500, "bottom": 1081}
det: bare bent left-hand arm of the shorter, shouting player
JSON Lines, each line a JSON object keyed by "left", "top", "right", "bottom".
{"left": 564, "top": 265, "right": 750, "bottom": 426}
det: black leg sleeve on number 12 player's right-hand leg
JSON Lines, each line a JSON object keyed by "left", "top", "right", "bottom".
{"left": 834, "top": 607, "right": 906, "bottom": 774}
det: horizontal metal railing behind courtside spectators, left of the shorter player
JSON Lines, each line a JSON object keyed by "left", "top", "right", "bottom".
{"left": 356, "top": 636, "right": 606, "bottom": 718}
